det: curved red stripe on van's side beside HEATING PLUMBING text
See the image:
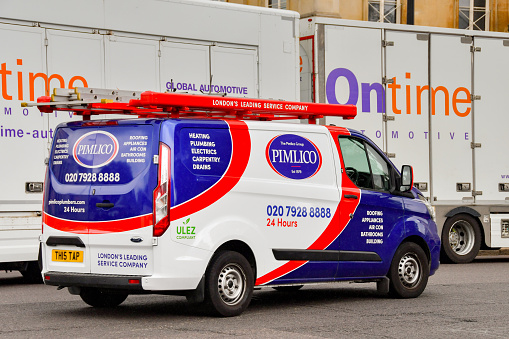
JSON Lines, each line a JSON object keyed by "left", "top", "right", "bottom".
{"left": 170, "top": 120, "right": 251, "bottom": 221}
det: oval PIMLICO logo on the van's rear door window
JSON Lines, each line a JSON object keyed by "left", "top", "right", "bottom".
{"left": 72, "top": 131, "right": 119, "bottom": 168}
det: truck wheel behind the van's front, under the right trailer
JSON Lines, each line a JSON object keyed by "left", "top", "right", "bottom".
{"left": 441, "top": 214, "right": 481, "bottom": 264}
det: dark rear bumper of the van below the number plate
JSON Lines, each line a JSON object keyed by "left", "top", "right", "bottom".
{"left": 44, "top": 271, "right": 143, "bottom": 291}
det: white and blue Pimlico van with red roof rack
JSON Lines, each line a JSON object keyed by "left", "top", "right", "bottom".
{"left": 36, "top": 92, "right": 440, "bottom": 316}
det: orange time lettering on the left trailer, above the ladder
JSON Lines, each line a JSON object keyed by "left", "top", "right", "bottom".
{"left": 0, "top": 59, "right": 88, "bottom": 101}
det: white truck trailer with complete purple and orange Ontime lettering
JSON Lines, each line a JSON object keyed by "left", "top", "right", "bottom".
{"left": 300, "top": 17, "right": 509, "bottom": 263}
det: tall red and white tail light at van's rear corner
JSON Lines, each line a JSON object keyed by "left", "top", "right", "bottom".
{"left": 154, "top": 143, "right": 171, "bottom": 237}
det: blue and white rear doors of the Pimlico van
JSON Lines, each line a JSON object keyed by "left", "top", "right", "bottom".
{"left": 43, "top": 120, "right": 159, "bottom": 275}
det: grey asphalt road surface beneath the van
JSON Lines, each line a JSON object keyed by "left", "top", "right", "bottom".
{"left": 0, "top": 256, "right": 509, "bottom": 339}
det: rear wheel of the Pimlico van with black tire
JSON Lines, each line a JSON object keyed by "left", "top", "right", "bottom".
{"left": 205, "top": 251, "right": 254, "bottom": 317}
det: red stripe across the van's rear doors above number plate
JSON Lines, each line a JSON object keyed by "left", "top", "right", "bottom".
{"left": 42, "top": 212, "right": 153, "bottom": 234}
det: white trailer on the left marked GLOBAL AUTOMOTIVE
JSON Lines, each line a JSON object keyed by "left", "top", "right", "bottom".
{"left": 0, "top": 0, "right": 299, "bottom": 280}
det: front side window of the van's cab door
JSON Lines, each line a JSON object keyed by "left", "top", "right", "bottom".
{"left": 339, "top": 137, "right": 392, "bottom": 191}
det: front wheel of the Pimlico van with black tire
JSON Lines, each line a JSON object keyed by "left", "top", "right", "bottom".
{"left": 388, "top": 242, "right": 429, "bottom": 298}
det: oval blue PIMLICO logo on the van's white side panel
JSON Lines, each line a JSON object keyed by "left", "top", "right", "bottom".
{"left": 265, "top": 134, "right": 322, "bottom": 180}
